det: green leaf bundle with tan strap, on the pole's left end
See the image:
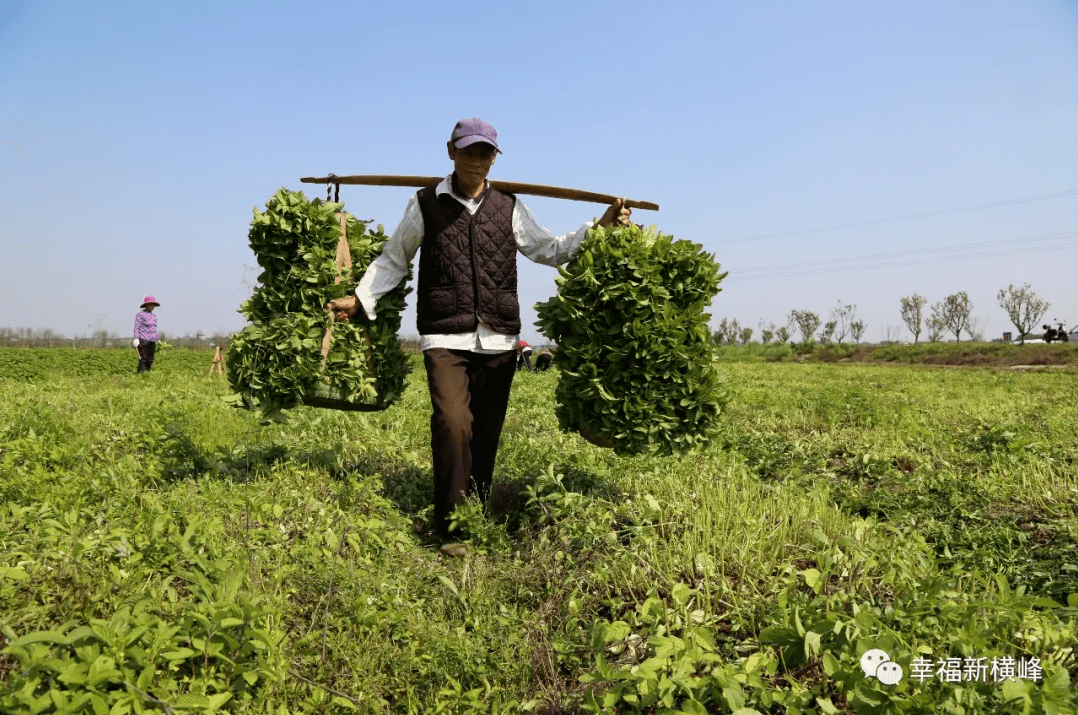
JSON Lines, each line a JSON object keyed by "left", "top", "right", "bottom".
{"left": 227, "top": 189, "right": 412, "bottom": 416}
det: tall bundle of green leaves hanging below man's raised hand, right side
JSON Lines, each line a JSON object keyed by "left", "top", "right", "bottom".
{"left": 536, "top": 225, "right": 730, "bottom": 454}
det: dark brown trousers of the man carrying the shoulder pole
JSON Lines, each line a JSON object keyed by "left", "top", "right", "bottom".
{"left": 423, "top": 348, "right": 516, "bottom": 536}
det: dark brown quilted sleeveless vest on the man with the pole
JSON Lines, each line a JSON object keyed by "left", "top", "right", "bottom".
{"left": 416, "top": 180, "right": 521, "bottom": 335}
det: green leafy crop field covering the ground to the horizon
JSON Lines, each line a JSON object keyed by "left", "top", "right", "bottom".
{"left": 0, "top": 346, "right": 1078, "bottom": 715}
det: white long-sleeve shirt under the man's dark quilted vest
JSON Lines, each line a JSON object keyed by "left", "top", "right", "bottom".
{"left": 356, "top": 175, "right": 593, "bottom": 353}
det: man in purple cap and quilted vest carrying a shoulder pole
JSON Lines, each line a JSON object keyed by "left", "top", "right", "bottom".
{"left": 327, "top": 118, "right": 631, "bottom": 555}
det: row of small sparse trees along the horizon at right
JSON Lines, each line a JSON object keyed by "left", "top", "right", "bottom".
{"left": 711, "top": 284, "right": 1051, "bottom": 345}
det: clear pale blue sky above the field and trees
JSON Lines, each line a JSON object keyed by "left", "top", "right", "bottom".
{"left": 0, "top": 0, "right": 1078, "bottom": 342}
